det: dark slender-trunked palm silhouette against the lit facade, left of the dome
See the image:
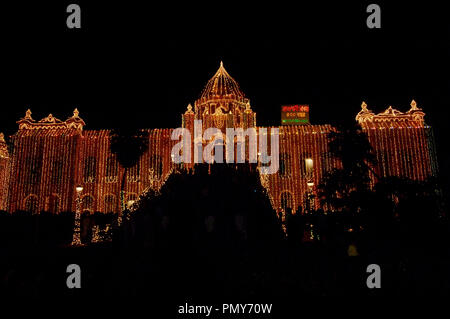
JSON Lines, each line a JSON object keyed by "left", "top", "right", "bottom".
{"left": 110, "top": 127, "right": 149, "bottom": 225}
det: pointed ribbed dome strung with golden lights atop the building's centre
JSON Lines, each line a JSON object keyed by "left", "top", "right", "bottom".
{"left": 200, "top": 62, "right": 244, "bottom": 99}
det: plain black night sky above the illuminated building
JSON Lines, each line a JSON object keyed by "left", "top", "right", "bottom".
{"left": 0, "top": 1, "right": 450, "bottom": 190}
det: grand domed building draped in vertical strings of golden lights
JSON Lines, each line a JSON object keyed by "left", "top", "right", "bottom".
{"left": 0, "top": 63, "right": 437, "bottom": 213}
